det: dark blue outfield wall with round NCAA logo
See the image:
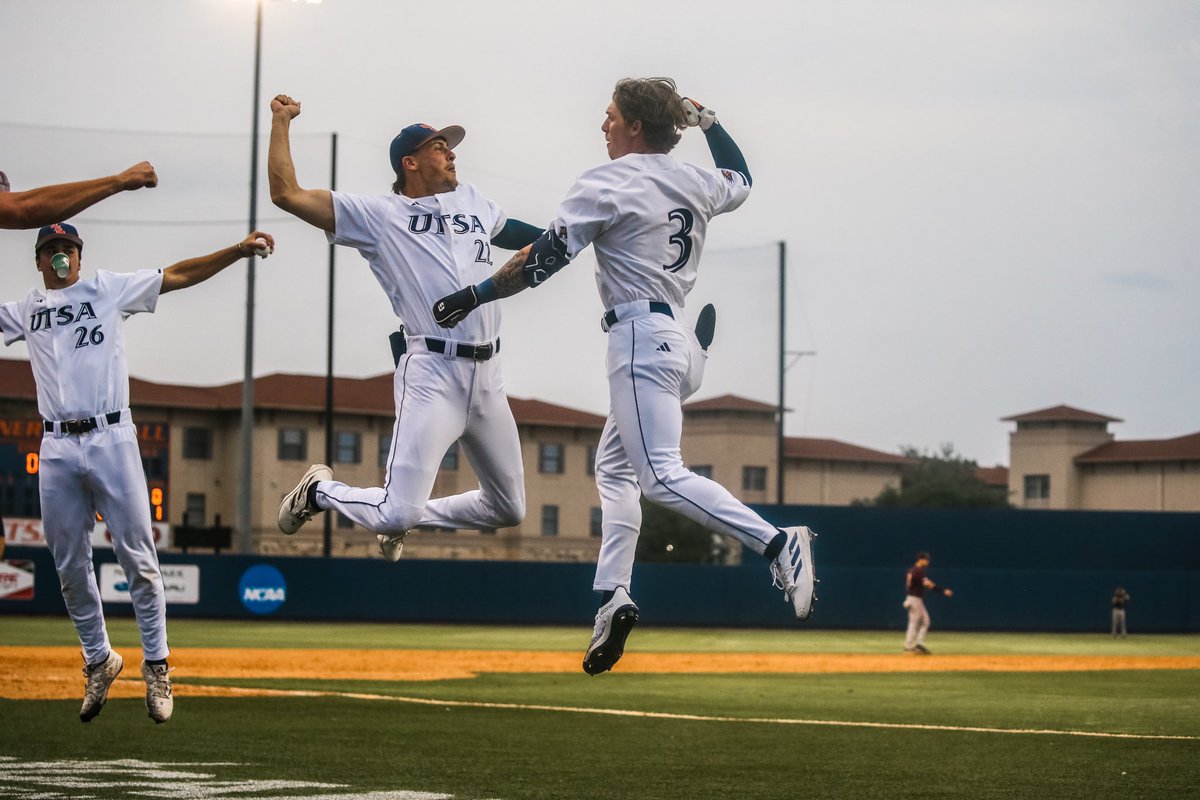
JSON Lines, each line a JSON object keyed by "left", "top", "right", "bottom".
{"left": 0, "top": 506, "right": 1200, "bottom": 633}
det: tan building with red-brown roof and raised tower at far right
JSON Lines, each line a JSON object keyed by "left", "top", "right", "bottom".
{"left": 1003, "top": 405, "right": 1200, "bottom": 511}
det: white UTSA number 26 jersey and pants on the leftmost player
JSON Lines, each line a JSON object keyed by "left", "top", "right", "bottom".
{"left": 0, "top": 270, "right": 169, "bottom": 663}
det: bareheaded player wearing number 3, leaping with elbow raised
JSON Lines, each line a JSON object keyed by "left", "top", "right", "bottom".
{"left": 433, "top": 78, "right": 815, "bottom": 675}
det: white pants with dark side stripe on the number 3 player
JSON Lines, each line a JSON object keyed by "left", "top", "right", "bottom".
{"left": 593, "top": 301, "right": 779, "bottom": 591}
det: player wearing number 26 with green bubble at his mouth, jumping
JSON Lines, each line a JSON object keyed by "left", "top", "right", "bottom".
{"left": 0, "top": 222, "right": 275, "bottom": 722}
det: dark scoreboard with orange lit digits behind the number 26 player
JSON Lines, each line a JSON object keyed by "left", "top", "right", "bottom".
{"left": 0, "top": 417, "right": 170, "bottom": 522}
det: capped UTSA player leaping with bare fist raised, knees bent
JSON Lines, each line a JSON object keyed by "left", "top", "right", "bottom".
{"left": 268, "top": 95, "right": 541, "bottom": 561}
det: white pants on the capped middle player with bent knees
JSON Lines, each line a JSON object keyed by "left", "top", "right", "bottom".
{"left": 317, "top": 347, "right": 524, "bottom": 535}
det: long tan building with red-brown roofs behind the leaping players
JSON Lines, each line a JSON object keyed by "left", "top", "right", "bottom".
{"left": 0, "top": 360, "right": 906, "bottom": 561}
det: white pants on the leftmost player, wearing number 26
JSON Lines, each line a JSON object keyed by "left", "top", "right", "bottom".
{"left": 38, "top": 409, "right": 170, "bottom": 663}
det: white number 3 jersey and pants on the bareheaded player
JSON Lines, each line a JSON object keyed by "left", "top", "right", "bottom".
{"left": 552, "top": 154, "right": 779, "bottom": 591}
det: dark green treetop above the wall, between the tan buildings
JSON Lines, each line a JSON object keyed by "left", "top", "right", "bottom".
{"left": 869, "top": 444, "right": 1008, "bottom": 509}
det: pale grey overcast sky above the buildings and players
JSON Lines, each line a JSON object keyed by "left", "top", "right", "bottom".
{"left": 0, "top": 0, "right": 1200, "bottom": 465}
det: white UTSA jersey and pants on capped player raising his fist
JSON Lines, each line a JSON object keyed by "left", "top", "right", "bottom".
{"left": 316, "top": 184, "right": 524, "bottom": 535}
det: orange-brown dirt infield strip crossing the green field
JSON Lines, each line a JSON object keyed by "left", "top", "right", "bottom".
{"left": 7, "top": 646, "right": 1200, "bottom": 699}
